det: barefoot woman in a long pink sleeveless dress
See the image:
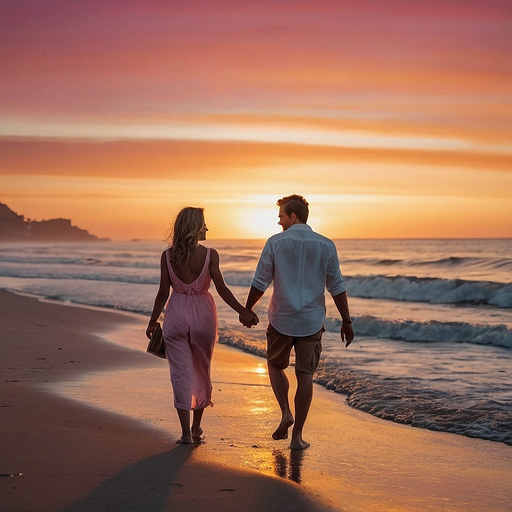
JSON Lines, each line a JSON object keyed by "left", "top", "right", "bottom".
{"left": 146, "top": 207, "right": 259, "bottom": 444}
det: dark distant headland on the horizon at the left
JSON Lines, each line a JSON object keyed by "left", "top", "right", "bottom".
{"left": 0, "top": 203, "right": 106, "bottom": 242}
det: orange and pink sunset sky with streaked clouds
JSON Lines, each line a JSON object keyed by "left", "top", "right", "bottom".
{"left": 0, "top": 0, "right": 512, "bottom": 239}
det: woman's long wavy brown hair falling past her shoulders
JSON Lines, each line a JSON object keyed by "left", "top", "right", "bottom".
{"left": 168, "top": 206, "right": 204, "bottom": 267}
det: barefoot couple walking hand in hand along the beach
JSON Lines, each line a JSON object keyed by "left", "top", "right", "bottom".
{"left": 146, "top": 195, "right": 354, "bottom": 450}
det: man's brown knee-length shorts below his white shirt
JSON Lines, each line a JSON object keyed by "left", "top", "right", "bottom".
{"left": 267, "top": 324, "right": 325, "bottom": 374}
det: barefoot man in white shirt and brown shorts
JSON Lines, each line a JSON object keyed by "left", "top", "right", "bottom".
{"left": 240, "top": 195, "right": 354, "bottom": 450}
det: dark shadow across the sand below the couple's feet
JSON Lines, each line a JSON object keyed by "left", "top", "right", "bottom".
{"left": 62, "top": 445, "right": 332, "bottom": 512}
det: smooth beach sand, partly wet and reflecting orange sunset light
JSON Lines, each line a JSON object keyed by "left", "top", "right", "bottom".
{"left": 0, "top": 290, "right": 512, "bottom": 512}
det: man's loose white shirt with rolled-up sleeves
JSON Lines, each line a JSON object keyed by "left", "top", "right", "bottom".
{"left": 252, "top": 224, "right": 347, "bottom": 337}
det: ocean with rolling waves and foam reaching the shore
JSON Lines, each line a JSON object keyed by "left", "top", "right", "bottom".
{"left": 0, "top": 239, "right": 512, "bottom": 445}
